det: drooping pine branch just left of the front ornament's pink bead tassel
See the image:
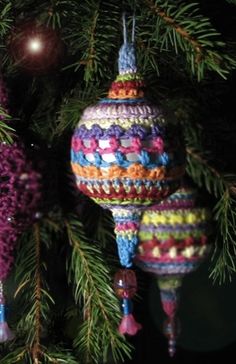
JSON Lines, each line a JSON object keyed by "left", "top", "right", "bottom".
{"left": 66, "top": 218, "right": 130, "bottom": 363}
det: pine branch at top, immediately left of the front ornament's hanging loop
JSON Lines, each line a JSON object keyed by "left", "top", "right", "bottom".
{"left": 65, "top": 0, "right": 120, "bottom": 83}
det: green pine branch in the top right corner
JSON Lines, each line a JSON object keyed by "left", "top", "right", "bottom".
{"left": 144, "top": 0, "right": 236, "bottom": 80}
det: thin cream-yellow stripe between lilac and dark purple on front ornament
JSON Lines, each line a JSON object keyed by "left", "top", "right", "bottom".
{"left": 79, "top": 115, "right": 166, "bottom": 130}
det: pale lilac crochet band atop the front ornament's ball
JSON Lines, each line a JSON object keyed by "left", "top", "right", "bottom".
{"left": 81, "top": 102, "right": 163, "bottom": 121}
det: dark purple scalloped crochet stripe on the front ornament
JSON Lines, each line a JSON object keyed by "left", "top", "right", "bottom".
{"left": 74, "top": 124, "right": 164, "bottom": 140}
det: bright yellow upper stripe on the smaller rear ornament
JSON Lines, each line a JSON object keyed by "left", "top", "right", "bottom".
{"left": 142, "top": 208, "right": 210, "bottom": 225}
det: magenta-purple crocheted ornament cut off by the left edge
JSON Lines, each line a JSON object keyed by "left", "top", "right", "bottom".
{"left": 0, "top": 79, "right": 41, "bottom": 342}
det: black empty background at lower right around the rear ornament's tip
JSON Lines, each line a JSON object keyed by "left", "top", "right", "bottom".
{"left": 126, "top": 258, "right": 236, "bottom": 364}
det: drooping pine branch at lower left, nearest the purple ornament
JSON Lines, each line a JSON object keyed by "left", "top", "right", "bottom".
{"left": 15, "top": 223, "right": 54, "bottom": 363}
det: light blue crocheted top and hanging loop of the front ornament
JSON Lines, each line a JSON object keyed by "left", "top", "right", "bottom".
{"left": 118, "top": 13, "right": 137, "bottom": 75}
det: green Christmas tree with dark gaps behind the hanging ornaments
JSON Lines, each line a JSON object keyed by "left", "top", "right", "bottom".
{"left": 0, "top": 0, "right": 236, "bottom": 364}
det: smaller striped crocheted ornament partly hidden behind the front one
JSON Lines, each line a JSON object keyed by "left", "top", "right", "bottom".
{"left": 134, "top": 187, "right": 210, "bottom": 356}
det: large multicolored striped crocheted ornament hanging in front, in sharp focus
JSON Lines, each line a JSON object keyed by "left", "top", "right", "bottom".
{"left": 71, "top": 15, "right": 185, "bottom": 334}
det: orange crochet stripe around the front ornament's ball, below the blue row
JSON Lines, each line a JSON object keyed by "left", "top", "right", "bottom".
{"left": 71, "top": 163, "right": 184, "bottom": 180}
